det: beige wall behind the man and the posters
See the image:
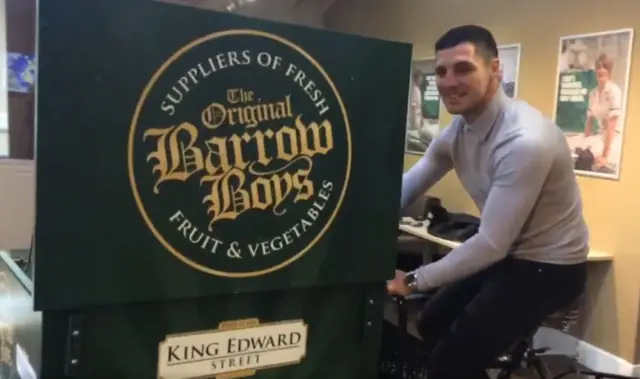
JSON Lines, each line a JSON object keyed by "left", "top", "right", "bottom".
{"left": 325, "top": 0, "right": 640, "bottom": 361}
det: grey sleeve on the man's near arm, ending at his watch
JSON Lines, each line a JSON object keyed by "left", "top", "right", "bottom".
{"left": 416, "top": 136, "right": 553, "bottom": 291}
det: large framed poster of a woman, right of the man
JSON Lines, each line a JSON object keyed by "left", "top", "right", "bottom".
{"left": 554, "top": 29, "right": 634, "bottom": 179}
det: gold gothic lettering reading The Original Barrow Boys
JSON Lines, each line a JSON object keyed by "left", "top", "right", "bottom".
{"left": 143, "top": 89, "right": 334, "bottom": 231}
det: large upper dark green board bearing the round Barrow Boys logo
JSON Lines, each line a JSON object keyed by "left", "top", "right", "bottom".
{"left": 35, "top": 0, "right": 411, "bottom": 309}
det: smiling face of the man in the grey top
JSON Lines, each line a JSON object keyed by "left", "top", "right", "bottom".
{"left": 436, "top": 43, "right": 500, "bottom": 114}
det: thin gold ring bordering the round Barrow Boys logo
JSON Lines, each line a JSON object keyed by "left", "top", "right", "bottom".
{"left": 127, "top": 29, "right": 352, "bottom": 278}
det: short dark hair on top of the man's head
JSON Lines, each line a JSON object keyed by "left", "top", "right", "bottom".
{"left": 435, "top": 25, "right": 498, "bottom": 59}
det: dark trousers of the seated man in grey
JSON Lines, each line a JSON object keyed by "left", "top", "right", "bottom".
{"left": 418, "top": 257, "right": 586, "bottom": 379}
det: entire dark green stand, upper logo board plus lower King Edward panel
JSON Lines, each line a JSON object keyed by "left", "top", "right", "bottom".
{"left": 34, "top": 0, "right": 411, "bottom": 379}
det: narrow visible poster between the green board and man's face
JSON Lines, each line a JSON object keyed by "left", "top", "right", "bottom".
{"left": 405, "top": 58, "right": 440, "bottom": 155}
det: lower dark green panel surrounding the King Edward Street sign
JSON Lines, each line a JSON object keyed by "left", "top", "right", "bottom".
{"left": 40, "top": 284, "right": 385, "bottom": 379}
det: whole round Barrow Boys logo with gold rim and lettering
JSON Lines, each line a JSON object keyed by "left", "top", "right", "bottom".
{"left": 128, "top": 30, "right": 351, "bottom": 277}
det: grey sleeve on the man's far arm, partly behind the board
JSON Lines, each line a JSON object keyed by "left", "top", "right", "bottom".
{"left": 400, "top": 134, "right": 453, "bottom": 209}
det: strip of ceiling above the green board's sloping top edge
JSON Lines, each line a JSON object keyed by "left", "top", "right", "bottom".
{"left": 162, "top": 0, "right": 335, "bottom": 27}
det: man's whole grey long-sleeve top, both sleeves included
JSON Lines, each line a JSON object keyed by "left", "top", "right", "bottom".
{"left": 401, "top": 91, "right": 589, "bottom": 290}
